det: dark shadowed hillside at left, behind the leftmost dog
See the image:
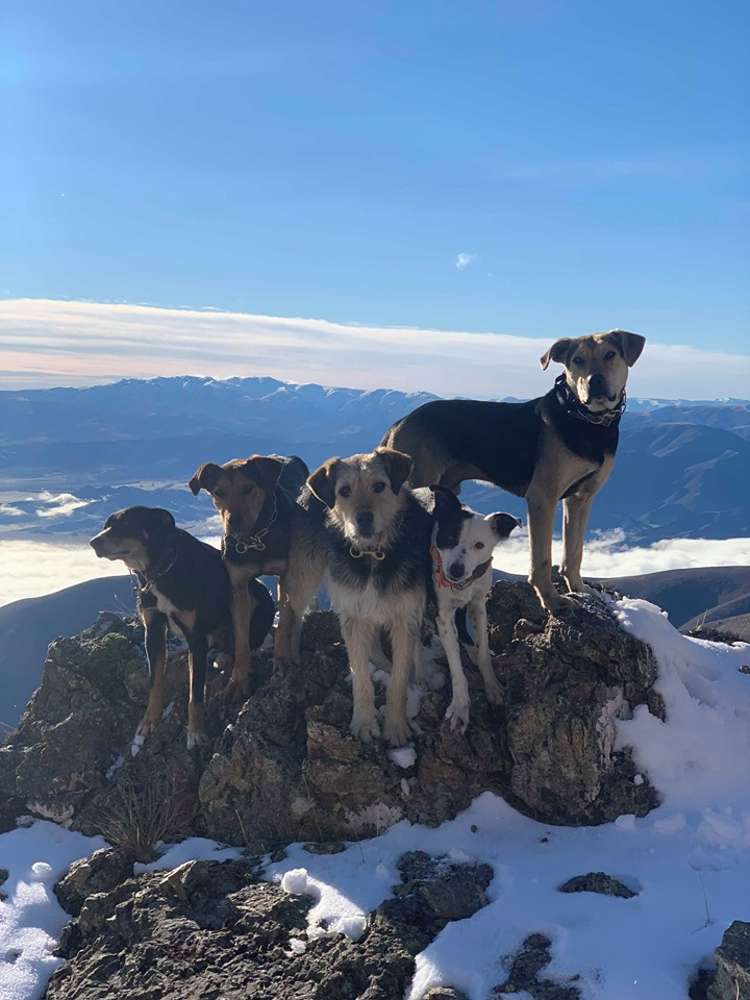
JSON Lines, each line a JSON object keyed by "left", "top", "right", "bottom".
{"left": 0, "top": 576, "right": 135, "bottom": 739}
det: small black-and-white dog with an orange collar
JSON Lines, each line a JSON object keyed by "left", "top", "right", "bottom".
{"left": 426, "top": 486, "right": 521, "bottom": 732}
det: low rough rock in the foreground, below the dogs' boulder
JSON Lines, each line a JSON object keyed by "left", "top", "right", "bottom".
{"left": 46, "top": 852, "right": 492, "bottom": 1000}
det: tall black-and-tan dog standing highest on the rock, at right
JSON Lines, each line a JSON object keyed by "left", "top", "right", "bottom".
{"left": 381, "top": 330, "right": 645, "bottom": 612}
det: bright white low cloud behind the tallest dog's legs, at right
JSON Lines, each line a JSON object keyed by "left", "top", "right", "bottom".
{"left": 493, "top": 530, "right": 750, "bottom": 577}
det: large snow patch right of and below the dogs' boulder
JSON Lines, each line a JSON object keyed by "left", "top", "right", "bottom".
{"left": 268, "top": 599, "right": 750, "bottom": 1000}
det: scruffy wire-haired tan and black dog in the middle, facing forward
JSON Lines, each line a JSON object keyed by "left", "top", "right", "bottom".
{"left": 308, "top": 448, "right": 433, "bottom": 746}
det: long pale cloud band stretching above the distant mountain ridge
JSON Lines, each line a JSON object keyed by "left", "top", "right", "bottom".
{"left": 0, "top": 299, "right": 750, "bottom": 399}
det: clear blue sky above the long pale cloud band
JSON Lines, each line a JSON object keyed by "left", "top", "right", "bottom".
{"left": 0, "top": 0, "right": 750, "bottom": 354}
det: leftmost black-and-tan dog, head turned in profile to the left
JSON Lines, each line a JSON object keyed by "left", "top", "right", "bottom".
{"left": 90, "top": 507, "right": 275, "bottom": 752}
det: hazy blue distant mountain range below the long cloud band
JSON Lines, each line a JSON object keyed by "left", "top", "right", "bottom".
{"left": 0, "top": 377, "right": 750, "bottom": 543}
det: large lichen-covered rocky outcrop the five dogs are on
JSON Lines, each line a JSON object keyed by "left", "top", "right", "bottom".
{"left": 0, "top": 582, "right": 663, "bottom": 856}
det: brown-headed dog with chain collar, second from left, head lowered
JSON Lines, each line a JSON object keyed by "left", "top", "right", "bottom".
{"left": 188, "top": 455, "right": 323, "bottom": 696}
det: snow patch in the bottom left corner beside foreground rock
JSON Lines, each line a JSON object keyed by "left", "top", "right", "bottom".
{"left": 0, "top": 820, "right": 106, "bottom": 1000}
